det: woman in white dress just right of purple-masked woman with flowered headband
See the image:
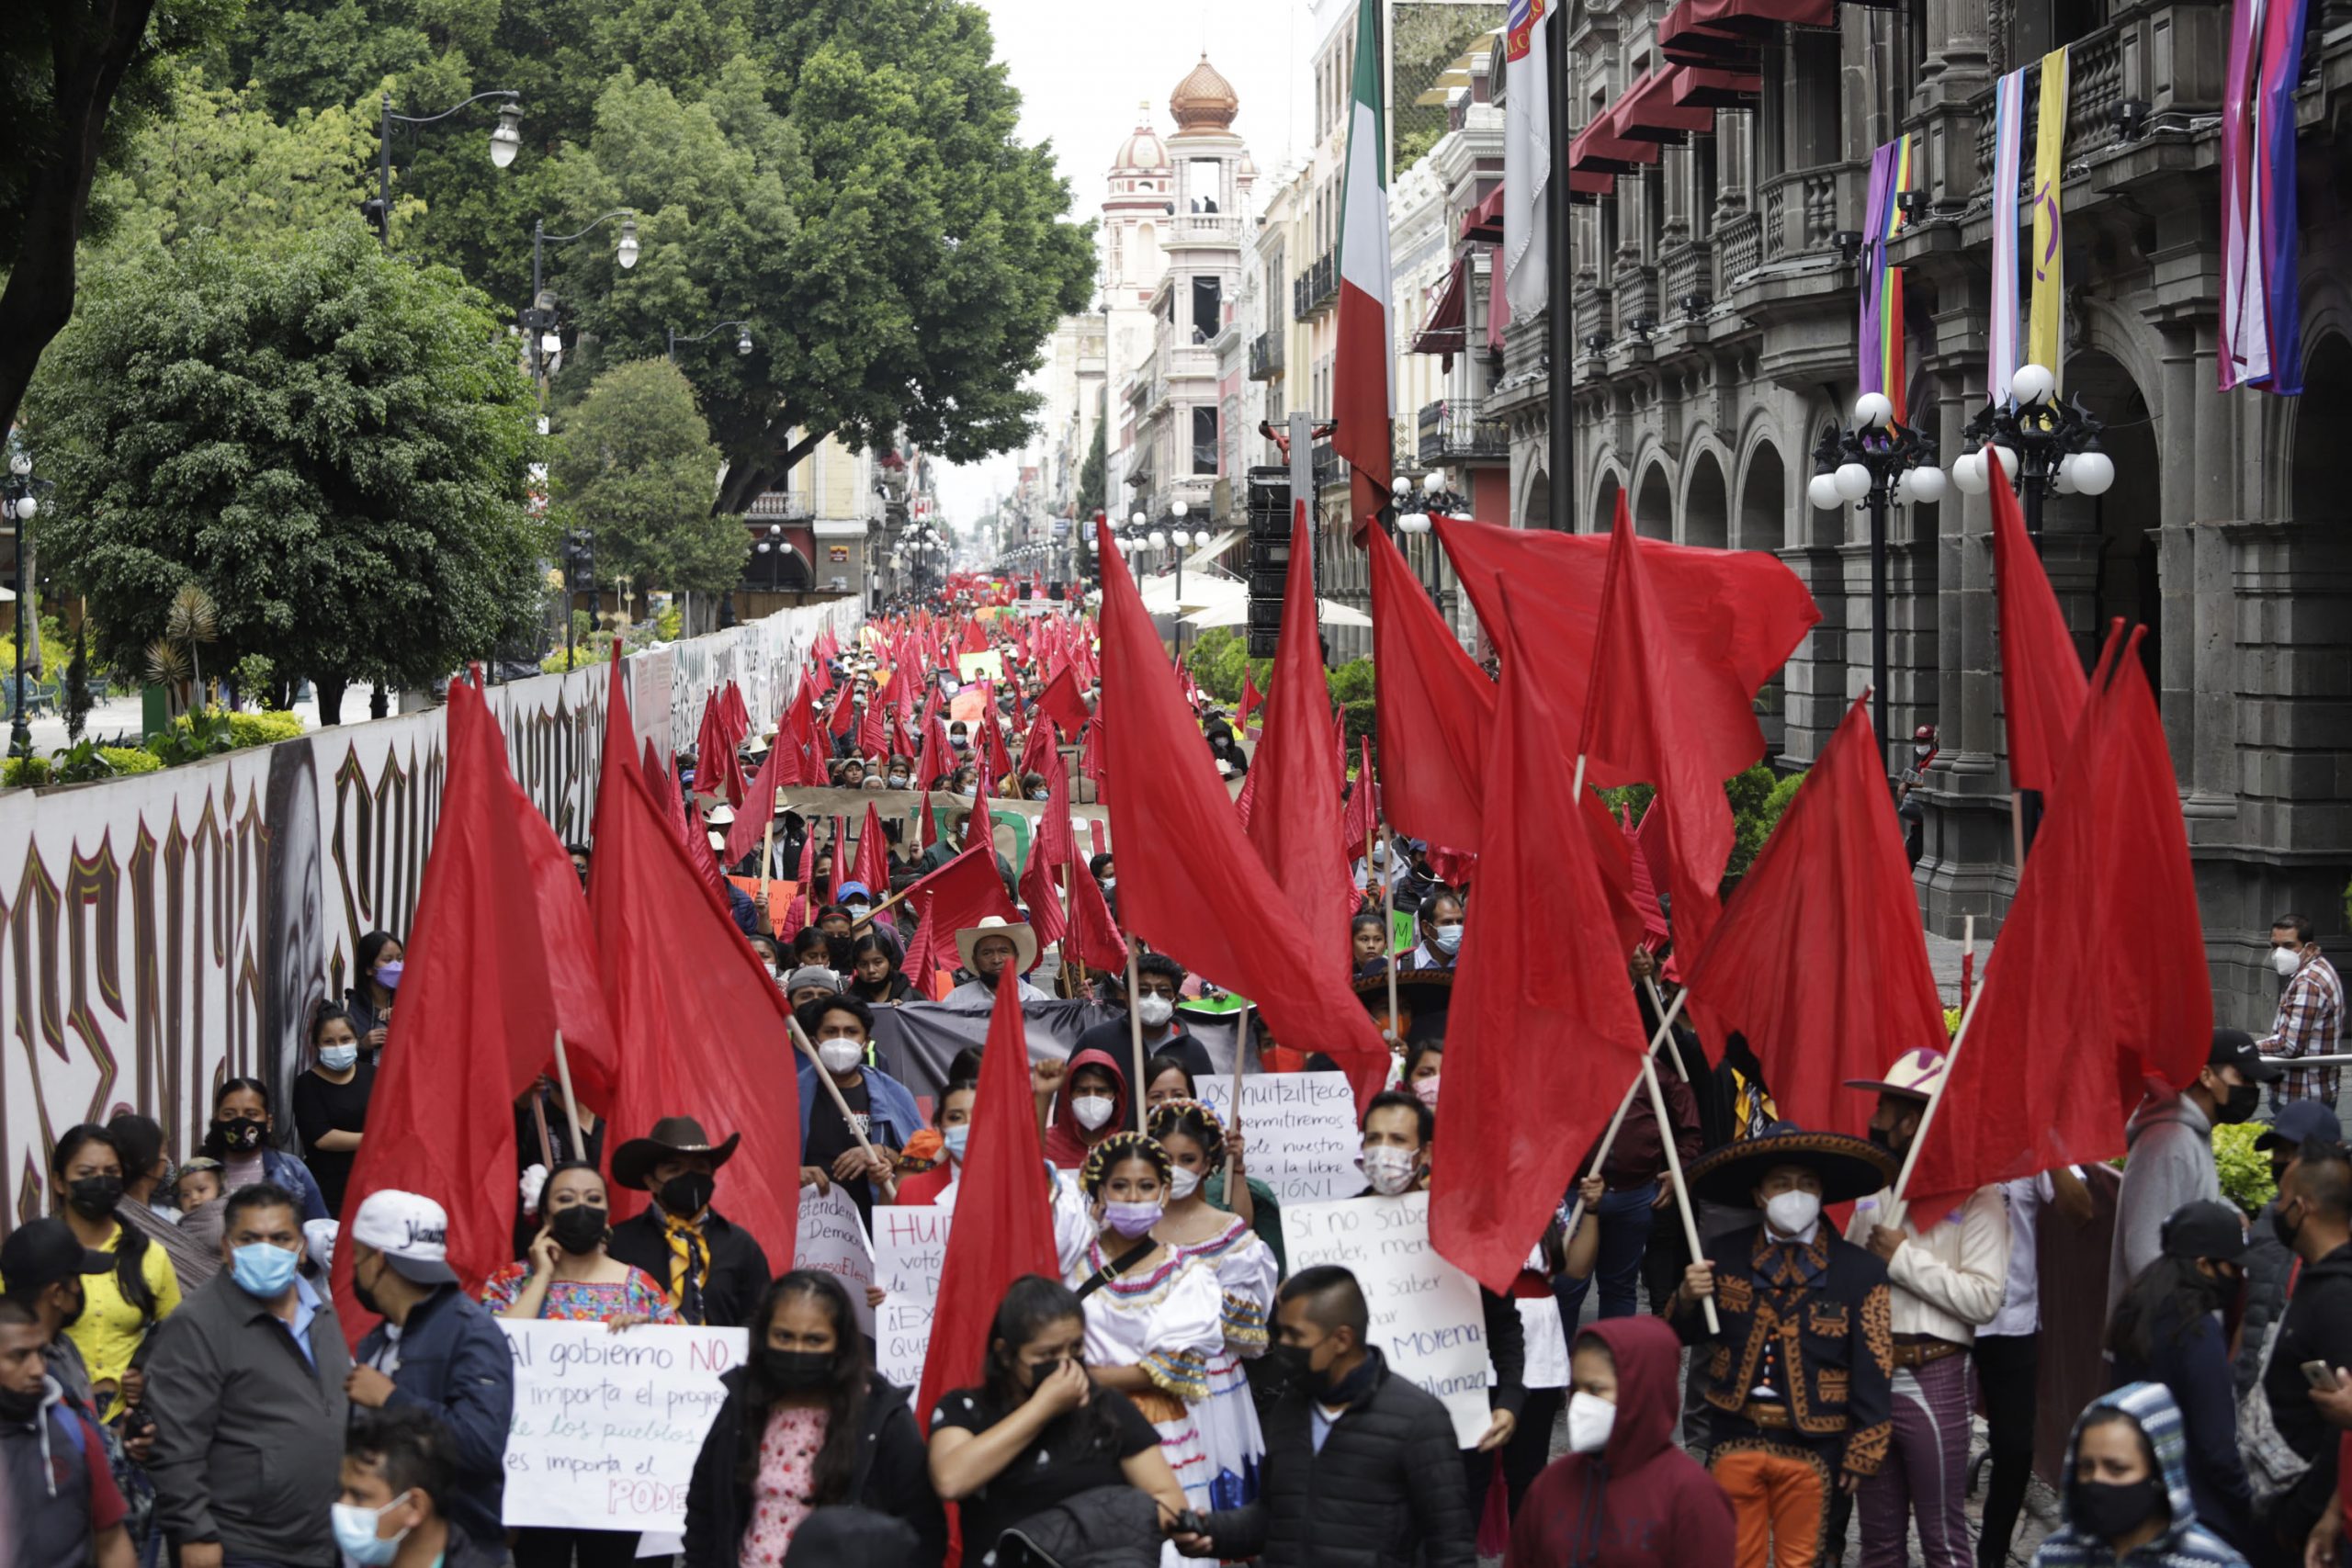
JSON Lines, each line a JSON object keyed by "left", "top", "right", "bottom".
{"left": 1150, "top": 1100, "right": 1280, "bottom": 1509}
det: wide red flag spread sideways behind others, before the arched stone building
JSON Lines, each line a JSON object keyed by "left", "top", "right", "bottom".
{"left": 1435, "top": 517, "right": 1820, "bottom": 787}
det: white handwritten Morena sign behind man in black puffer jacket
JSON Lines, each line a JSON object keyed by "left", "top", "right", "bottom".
{"left": 1288, "top": 1194, "right": 1487, "bottom": 1448}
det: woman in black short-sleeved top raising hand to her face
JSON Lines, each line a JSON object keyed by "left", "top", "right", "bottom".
{"left": 929, "top": 1274, "right": 1185, "bottom": 1568}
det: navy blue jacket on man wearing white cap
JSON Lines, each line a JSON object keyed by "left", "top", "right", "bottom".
{"left": 353, "top": 1286, "right": 515, "bottom": 1542}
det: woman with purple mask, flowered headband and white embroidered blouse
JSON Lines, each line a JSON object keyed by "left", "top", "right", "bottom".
{"left": 1070, "top": 1134, "right": 1226, "bottom": 1512}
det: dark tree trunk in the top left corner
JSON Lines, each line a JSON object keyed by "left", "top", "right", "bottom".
{"left": 0, "top": 0, "right": 238, "bottom": 446}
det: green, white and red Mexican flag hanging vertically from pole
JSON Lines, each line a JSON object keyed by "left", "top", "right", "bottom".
{"left": 1331, "top": 0, "right": 1397, "bottom": 534}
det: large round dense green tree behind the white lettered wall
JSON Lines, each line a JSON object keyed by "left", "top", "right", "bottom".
{"left": 26, "top": 216, "right": 550, "bottom": 722}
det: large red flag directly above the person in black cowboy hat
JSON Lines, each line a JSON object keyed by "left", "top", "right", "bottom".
{"left": 593, "top": 644, "right": 799, "bottom": 1274}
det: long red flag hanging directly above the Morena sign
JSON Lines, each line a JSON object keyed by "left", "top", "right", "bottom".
{"left": 1430, "top": 588, "right": 1649, "bottom": 1291}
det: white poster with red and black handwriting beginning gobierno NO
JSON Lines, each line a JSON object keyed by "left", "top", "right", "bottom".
{"left": 499, "top": 1319, "right": 748, "bottom": 1533}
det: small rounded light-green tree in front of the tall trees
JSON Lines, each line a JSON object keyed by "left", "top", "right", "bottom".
{"left": 548, "top": 360, "right": 748, "bottom": 594}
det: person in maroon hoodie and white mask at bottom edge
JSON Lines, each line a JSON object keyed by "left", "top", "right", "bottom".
{"left": 1503, "top": 1316, "right": 1734, "bottom": 1568}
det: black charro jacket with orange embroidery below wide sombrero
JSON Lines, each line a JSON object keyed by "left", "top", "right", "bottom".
{"left": 1675, "top": 1220, "right": 1894, "bottom": 1476}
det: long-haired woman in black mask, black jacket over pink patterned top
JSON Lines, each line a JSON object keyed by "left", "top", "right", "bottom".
{"left": 684, "top": 1269, "right": 948, "bottom": 1568}
